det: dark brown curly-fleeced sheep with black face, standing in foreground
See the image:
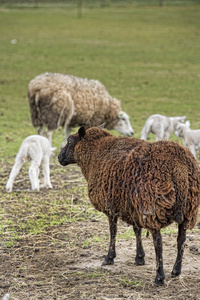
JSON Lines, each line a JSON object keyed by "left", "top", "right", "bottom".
{"left": 58, "top": 126, "right": 200, "bottom": 285}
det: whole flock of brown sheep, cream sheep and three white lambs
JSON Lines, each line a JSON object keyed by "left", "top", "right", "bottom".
{"left": 6, "top": 73, "right": 200, "bottom": 285}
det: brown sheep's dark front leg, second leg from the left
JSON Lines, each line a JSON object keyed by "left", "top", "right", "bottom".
{"left": 133, "top": 225, "right": 145, "bottom": 266}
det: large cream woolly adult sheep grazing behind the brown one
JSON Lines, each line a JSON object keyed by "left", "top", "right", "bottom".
{"left": 28, "top": 73, "right": 134, "bottom": 147}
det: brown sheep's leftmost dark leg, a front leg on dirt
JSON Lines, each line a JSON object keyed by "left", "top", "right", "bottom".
{"left": 102, "top": 216, "right": 117, "bottom": 266}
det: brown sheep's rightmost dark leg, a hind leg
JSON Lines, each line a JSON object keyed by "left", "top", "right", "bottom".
{"left": 171, "top": 224, "right": 186, "bottom": 277}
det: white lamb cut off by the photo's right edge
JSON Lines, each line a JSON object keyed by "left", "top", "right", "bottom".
{"left": 175, "top": 121, "right": 200, "bottom": 157}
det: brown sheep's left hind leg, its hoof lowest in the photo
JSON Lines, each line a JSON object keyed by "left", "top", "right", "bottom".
{"left": 152, "top": 229, "right": 165, "bottom": 285}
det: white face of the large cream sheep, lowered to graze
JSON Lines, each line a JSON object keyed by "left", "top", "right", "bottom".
{"left": 114, "top": 111, "right": 134, "bottom": 136}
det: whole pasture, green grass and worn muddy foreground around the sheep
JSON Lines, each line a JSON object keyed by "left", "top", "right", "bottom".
{"left": 0, "top": 4, "right": 200, "bottom": 300}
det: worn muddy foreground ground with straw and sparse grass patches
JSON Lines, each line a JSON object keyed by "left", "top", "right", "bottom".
{"left": 0, "top": 159, "right": 200, "bottom": 300}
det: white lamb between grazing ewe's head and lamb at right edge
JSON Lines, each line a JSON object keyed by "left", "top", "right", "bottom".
{"left": 141, "top": 114, "right": 186, "bottom": 141}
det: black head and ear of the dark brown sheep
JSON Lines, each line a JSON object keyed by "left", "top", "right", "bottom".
{"left": 58, "top": 126, "right": 85, "bottom": 166}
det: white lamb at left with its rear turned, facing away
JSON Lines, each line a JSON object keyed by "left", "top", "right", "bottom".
{"left": 6, "top": 135, "right": 55, "bottom": 193}
